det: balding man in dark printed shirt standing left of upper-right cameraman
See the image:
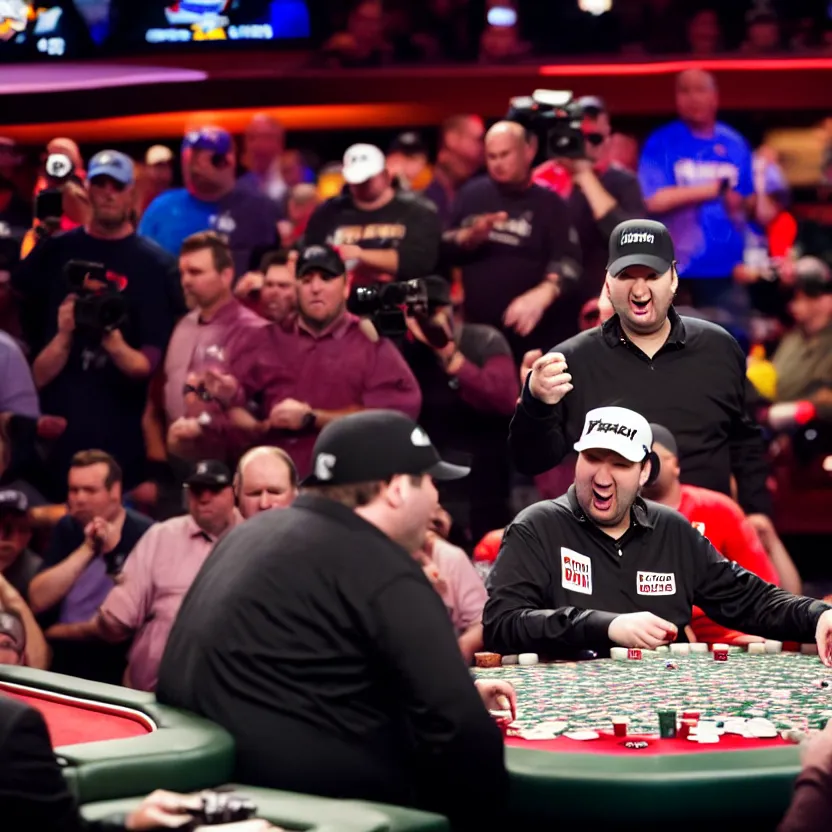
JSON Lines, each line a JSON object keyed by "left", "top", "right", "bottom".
{"left": 443, "top": 121, "right": 580, "bottom": 363}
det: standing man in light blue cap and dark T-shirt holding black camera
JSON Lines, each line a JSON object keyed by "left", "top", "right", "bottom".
{"left": 12, "top": 150, "right": 184, "bottom": 502}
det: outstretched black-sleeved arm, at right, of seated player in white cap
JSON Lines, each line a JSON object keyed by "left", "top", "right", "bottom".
{"left": 686, "top": 529, "right": 832, "bottom": 644}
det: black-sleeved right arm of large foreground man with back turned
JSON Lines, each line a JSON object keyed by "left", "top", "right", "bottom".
{"left": 369, "top": 574, "right": 508, "bottom": 828}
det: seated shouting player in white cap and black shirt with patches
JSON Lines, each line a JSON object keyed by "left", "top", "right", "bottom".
{"left": 483, "top": 407, "right": 832, "bottom": 666}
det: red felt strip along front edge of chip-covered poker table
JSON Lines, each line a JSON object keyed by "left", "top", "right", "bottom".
{"left": 506, "top": 729, "right": 785, "bottom": 755}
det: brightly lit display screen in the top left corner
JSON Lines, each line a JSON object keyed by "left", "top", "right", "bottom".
{"left": 0, "top": 0, "right": 311, "bottom": 58}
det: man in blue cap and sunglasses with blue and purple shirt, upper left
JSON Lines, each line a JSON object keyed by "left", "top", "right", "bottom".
{"left": 139, "top": 127, "right": 282, "bottom": 274}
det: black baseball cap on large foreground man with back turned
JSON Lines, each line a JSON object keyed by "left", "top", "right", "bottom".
{"left": 301, "top": 410, "right": 471, "bottom": 486}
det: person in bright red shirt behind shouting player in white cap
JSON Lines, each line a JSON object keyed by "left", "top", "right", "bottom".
{"left": 642, "top": 424, "right": 801, "bottom": 644}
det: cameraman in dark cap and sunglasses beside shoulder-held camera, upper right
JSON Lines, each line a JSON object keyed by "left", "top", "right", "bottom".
{"left": 532, "top": 95, "right": 647, "bottom": 316}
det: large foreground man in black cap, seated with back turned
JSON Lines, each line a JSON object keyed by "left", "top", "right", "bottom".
{"left": 157, "top": 410, "right": 514, "bottom": 829}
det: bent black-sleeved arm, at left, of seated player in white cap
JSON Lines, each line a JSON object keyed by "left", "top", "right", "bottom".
{"left": 483, "top": 522, "right": 616, "bottom": 656}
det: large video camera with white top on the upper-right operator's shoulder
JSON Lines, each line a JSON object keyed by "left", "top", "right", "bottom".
{"left": 506, "top": 90, "right": 586, "bottom": 159}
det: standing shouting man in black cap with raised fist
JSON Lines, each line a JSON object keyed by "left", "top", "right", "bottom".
{"left": 510, "top": 220, "right": 770, "bottom": 514}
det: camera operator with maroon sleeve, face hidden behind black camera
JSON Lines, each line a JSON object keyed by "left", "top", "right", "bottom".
{"left": 401, "top": 277, "right": 519, "bottom": 543}
